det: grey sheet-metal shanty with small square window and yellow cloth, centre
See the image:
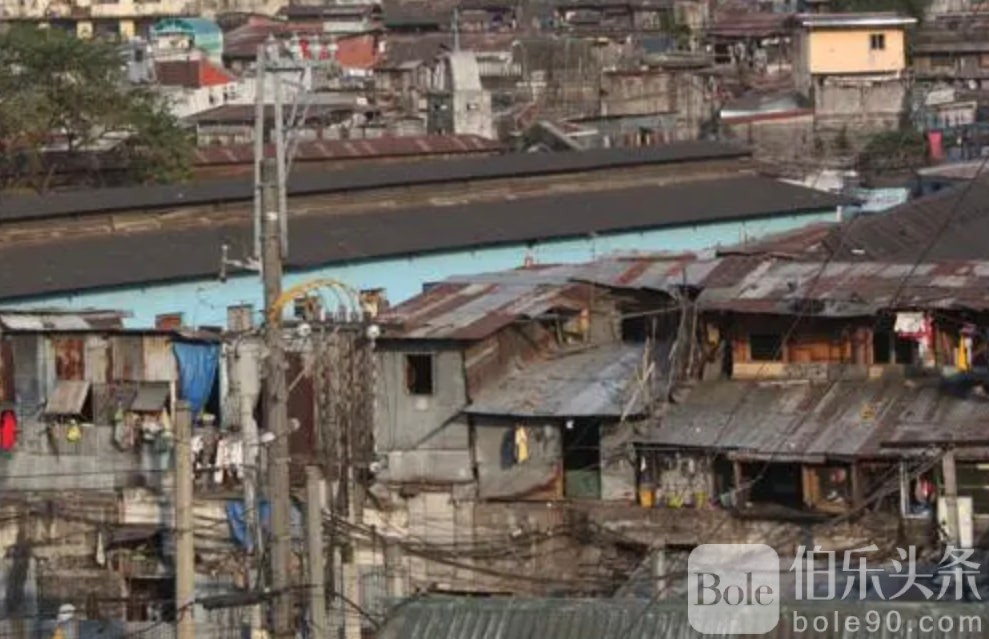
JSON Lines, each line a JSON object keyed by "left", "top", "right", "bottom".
{"left": 375, "top": 260, "right": 692, "bottom": 501}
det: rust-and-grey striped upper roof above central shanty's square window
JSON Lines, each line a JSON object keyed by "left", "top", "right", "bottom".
{"left": 379, "top": 283, "right": 581, "bottom": 340}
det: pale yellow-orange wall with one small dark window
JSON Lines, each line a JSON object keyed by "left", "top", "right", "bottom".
{"left": 801, "top": 28, "right": 906, "bottom": 75}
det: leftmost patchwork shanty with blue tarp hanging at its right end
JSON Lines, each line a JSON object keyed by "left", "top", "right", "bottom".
{"left": 0, "top": 311, "right": 219, "bottom": 491}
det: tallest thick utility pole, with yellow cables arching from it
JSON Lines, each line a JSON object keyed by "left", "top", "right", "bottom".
{"left": 261, "top": 158, "right": 294, "bottom": 639}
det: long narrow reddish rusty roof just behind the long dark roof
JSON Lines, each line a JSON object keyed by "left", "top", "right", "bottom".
{"left": 193, "top": 135, "right": 504, "bottom": 166}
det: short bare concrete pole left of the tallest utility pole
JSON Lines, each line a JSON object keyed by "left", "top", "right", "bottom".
{"left": 174, "top": 400, "right": 196, "bottom": 639}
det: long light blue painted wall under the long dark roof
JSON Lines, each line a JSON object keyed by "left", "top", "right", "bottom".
{"left": 0, "top": 210, "right": 837, "bottom": 328}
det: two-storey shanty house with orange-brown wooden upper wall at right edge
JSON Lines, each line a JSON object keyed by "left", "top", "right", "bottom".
{"left": 639, "top": 258, "right": 989, "bottom": 536}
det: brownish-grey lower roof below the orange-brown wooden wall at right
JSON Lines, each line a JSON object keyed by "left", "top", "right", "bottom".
{"left": 646, "top": 378, "right": 989, "bottom": 461}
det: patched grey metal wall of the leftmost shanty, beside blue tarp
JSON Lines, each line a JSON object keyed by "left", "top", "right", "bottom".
{"left": 0, "top": 333, "right": 178, "bottom": 491}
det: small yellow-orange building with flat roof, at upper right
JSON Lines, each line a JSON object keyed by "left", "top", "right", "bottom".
{"left": 794, "top": 13, "right": 917, "bottom": 92}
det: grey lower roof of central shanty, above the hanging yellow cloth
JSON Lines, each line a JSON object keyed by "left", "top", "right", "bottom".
{"left": 465, "top": 344, "right": 648, "bottom": 417}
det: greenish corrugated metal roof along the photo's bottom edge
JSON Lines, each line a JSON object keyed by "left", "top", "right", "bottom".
{"left": 378, "top": 597, "right": 989, "bottom": 639}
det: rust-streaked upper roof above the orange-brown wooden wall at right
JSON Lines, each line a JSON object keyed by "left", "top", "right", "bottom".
{"left": 699, "top": 260, "right": 989, "bottom": 317}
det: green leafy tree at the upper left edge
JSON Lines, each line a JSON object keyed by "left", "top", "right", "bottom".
{"left": 0, "top": 27, "right": 193, "bottom": 191}
